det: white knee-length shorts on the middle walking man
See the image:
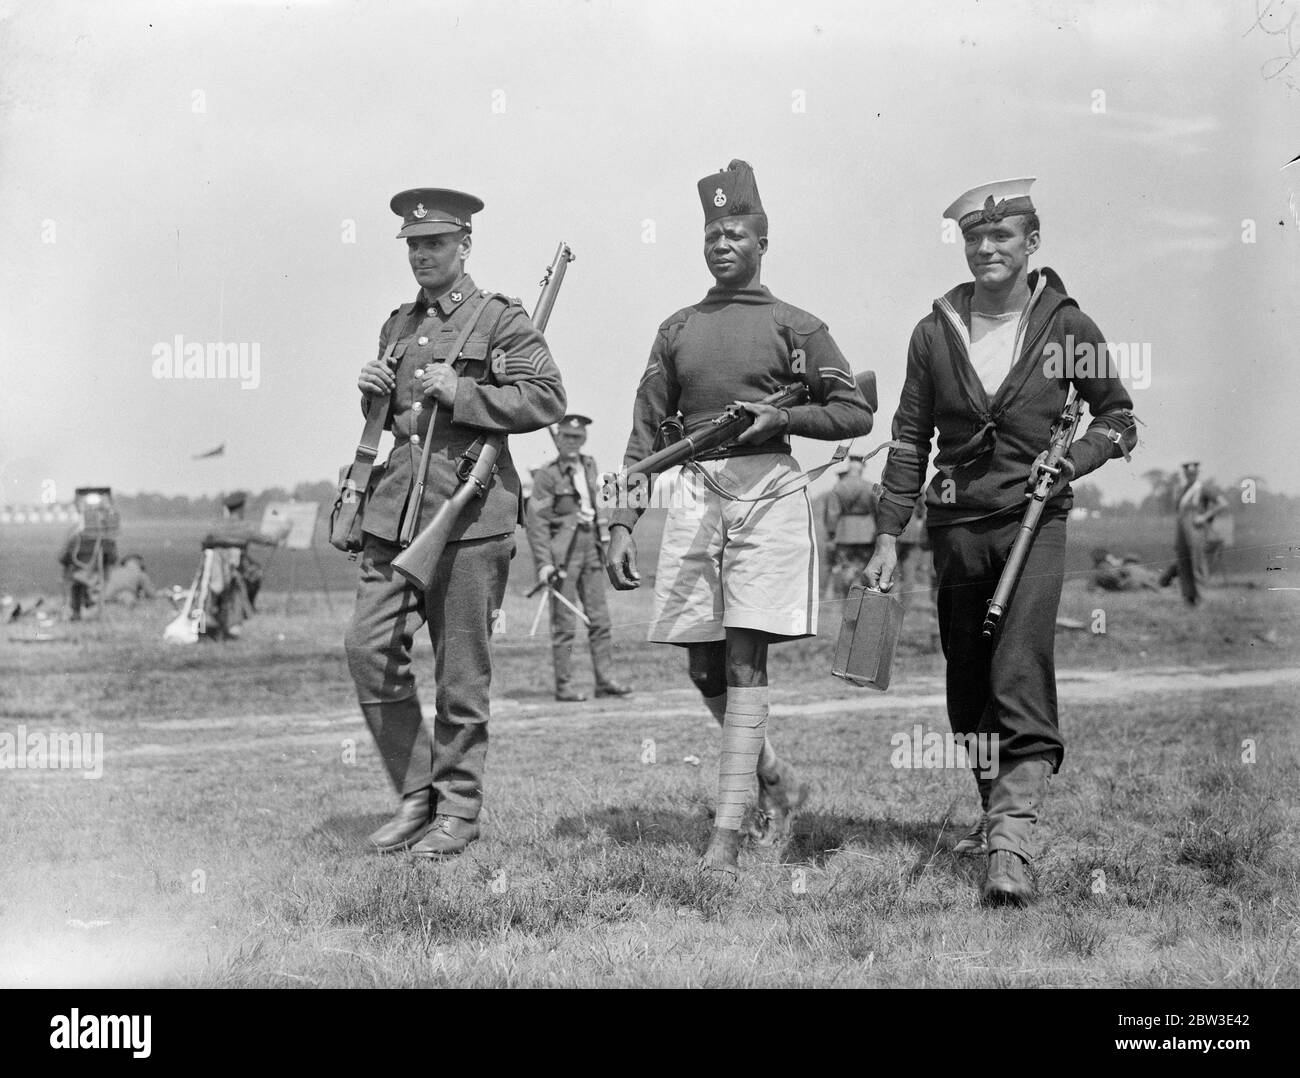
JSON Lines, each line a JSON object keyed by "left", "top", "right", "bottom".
{"left": 649, "top": 453, "right": 818, "bottom": 644}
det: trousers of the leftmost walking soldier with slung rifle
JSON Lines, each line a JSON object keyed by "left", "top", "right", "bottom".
{"left": 345, "top": 534, "right": 515, "bottom": 819}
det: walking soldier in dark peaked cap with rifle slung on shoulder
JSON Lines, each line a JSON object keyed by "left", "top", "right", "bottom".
{"left": 345, "top": 187, "right": 566, "bottom": 858}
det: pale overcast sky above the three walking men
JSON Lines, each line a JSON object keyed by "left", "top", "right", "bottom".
{"left": 0, "top": 0, "right": 1300, "bottom": 502}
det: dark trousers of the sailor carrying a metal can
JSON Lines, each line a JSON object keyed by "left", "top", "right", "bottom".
{"left": 930, "top": 514, "right": 1065, "bottom": 770}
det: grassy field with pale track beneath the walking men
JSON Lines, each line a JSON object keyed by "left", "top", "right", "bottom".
{"left": 0, "top": 521, "right": 1300, "bottom": 987}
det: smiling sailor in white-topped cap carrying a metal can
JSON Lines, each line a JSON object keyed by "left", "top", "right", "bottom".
{"left": 866, "top": 178, "right": 1138, "bottom": 905}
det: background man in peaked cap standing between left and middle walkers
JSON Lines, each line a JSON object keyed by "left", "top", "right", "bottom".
{"left": 528, "top": 415, "right": 632, "bottom": 701}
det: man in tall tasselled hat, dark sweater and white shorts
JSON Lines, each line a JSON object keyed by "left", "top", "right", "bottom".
{"left": 610, "top": 161, "right": 872, "bottom": 878}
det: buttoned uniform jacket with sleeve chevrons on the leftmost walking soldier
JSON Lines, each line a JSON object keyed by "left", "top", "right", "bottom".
{"left": 365, "top": 274, "right": 568, "bottom": 542}
